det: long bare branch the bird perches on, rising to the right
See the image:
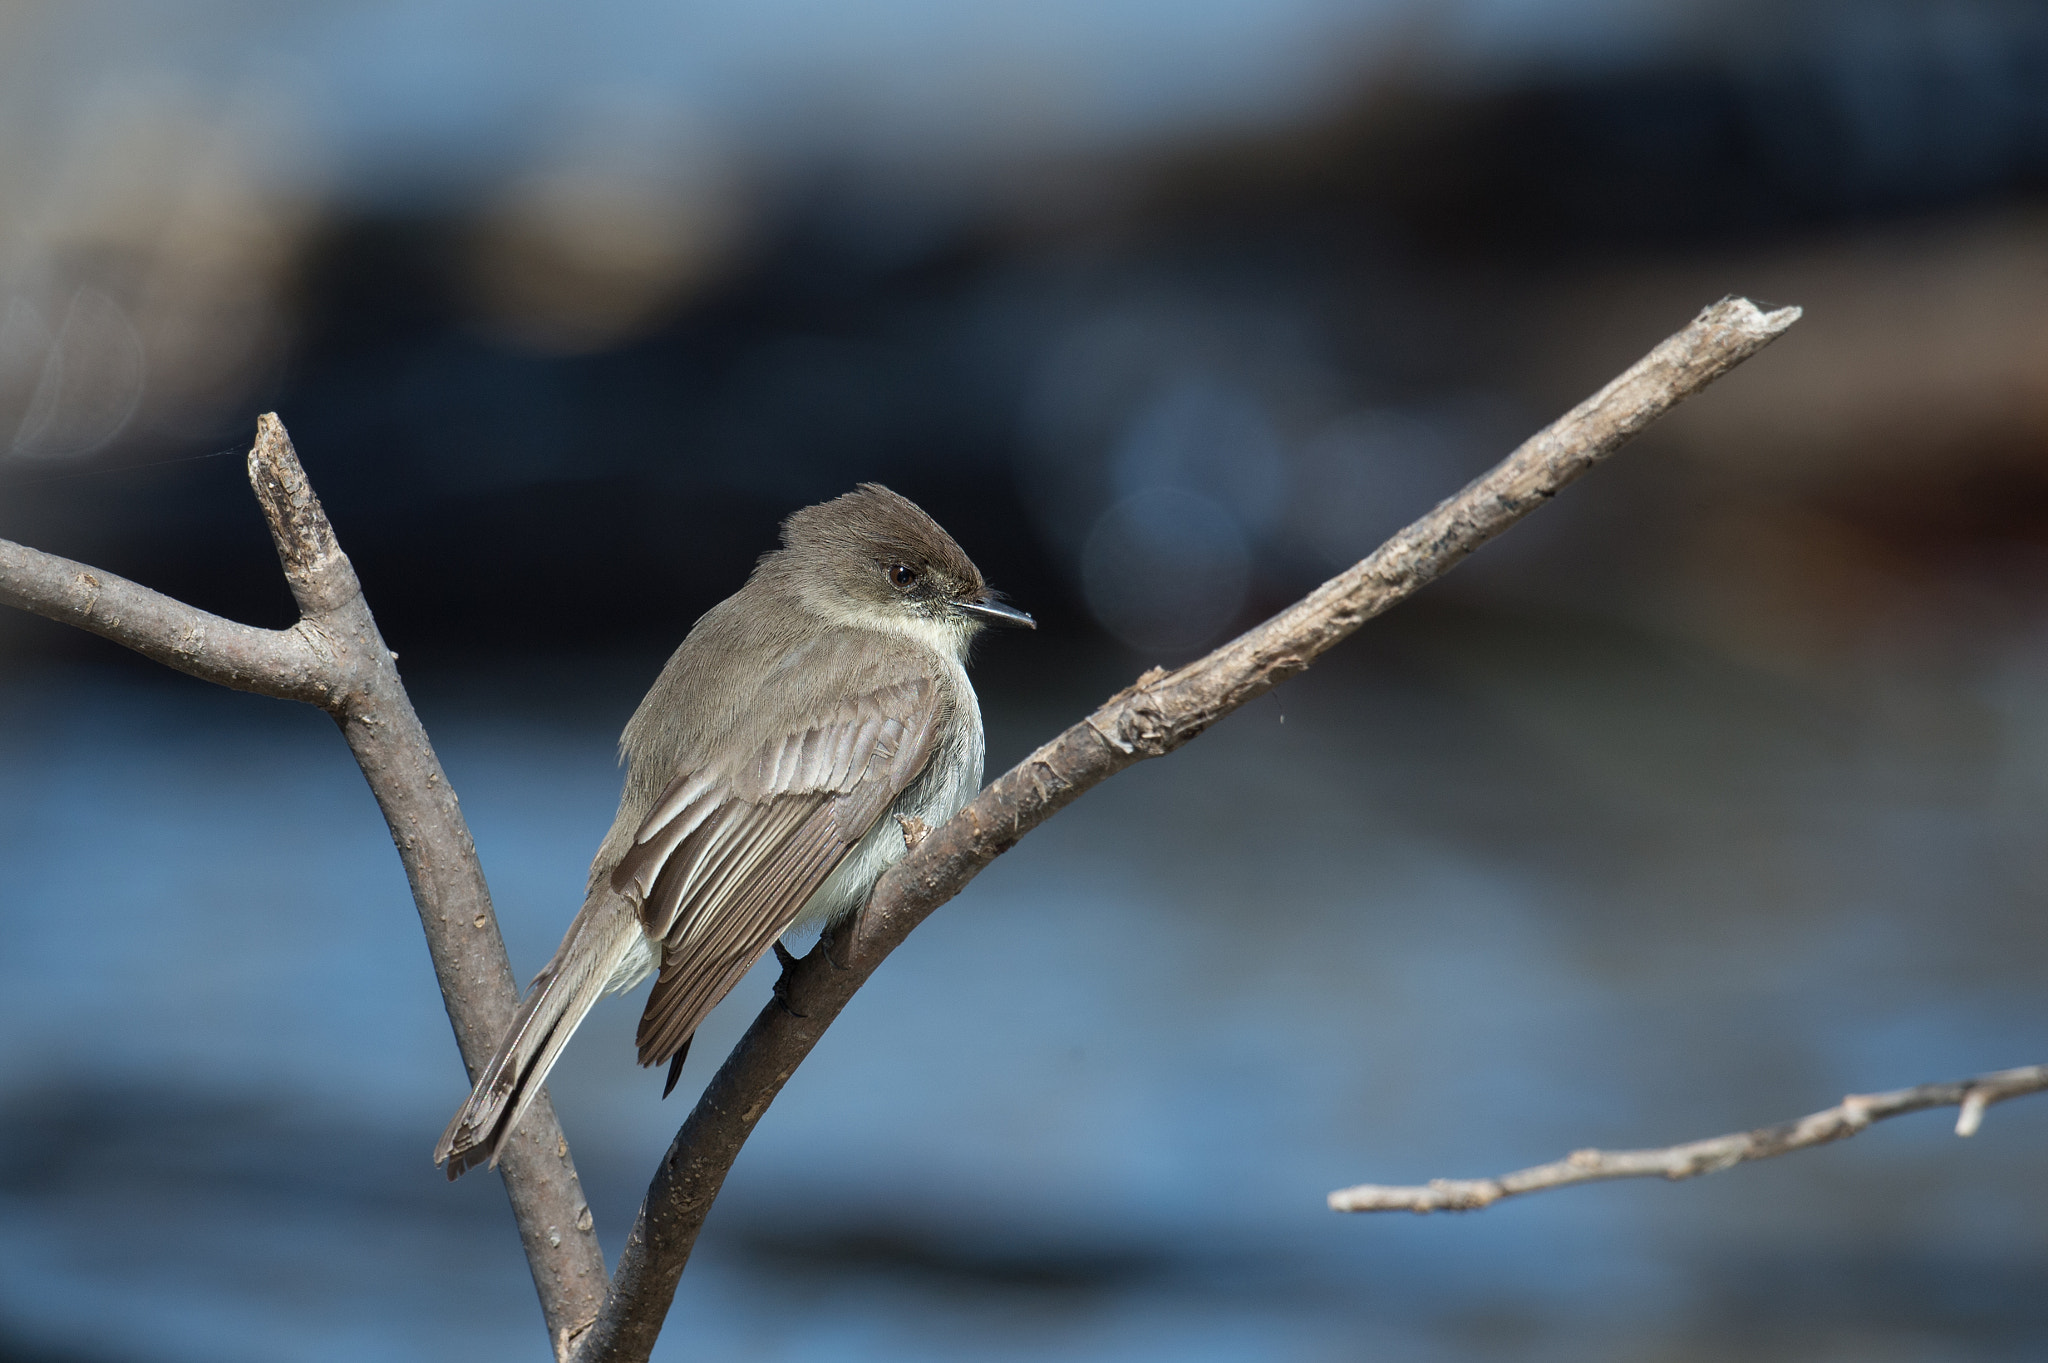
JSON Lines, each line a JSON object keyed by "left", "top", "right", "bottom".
{"left": 575, "top": 299, "right": 1800, "bottom": 1363}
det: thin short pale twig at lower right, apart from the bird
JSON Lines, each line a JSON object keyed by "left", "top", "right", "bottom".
{"left": 1329, "top": 1064, "right": 2048, "bottom": 1214}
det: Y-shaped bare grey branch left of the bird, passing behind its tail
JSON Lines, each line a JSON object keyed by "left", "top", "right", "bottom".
{"left": 0, "top": 415, "right": 604, "bottom": 1351}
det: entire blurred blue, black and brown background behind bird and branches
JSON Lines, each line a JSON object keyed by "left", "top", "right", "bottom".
{"left": 0, "top": 0, "right": 2048, "bottom": 1363}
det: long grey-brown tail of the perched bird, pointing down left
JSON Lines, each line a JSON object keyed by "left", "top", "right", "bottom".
{"left": 434, "top": 903, "right": 639, "bottom": 1181}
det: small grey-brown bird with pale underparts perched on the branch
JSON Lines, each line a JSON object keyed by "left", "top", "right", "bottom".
{"left": 434, "top": 483, "right": 1032, "bottom": 1179}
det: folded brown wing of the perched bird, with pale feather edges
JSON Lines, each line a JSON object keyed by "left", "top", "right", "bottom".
{"left": 612, "top": 675, "right": 940, "bottom": 1064}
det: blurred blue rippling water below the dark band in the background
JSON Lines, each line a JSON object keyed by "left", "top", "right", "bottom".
{"left": 0, "top": 614, "right": 2048, "bottom": 1363}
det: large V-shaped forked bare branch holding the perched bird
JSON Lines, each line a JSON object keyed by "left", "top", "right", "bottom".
{"left": 0, "top": 299, "right": 1826, "bottom": 1363}
